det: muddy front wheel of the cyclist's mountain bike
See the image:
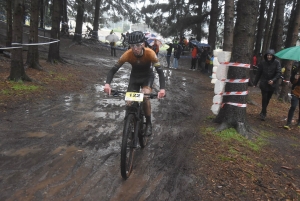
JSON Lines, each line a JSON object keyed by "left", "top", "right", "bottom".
{"left": 121, "top": 114, "right": 136, "bottom": 179}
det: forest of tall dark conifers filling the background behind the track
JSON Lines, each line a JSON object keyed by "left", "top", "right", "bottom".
{"left": 0, "top": 0, "right": 300, "bottom": 135}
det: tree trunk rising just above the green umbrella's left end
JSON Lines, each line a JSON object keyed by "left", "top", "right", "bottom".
{"left": 270, "top": 0, "right": 286, "bottom": 52}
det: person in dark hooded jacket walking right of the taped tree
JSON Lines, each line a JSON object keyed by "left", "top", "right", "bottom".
{"left": 253, "top": 49, "right": 281, "bottom": 121}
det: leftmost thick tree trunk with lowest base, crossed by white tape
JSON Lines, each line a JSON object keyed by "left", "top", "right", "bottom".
{"left": 8, "top": 0, "right": 31, "bottom": 82}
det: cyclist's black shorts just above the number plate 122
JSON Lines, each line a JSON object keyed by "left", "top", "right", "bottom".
{"left": 127, "top": 73, "right": 154, "bottom": 92}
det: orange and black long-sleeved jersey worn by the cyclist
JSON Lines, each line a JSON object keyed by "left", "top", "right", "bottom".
{"left": 106, "top": 48, "right": 165, "bottom": 89}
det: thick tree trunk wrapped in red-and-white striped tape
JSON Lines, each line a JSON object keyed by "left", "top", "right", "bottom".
{"left": 215, "top": 0, "right": 258, "bottom": 138}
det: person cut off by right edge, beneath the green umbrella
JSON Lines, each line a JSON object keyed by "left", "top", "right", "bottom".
{"left": 284, "top": 62, "right": 300, "bottom": 129}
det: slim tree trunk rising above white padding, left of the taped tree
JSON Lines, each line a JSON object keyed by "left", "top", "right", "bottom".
{"left": 223, "top": 0, "right": 234, "bottom": 52}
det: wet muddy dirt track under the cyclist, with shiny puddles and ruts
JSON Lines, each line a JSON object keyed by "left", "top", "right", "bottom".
{"left": 0, "top": 52, "right": 212, "bottom": 201}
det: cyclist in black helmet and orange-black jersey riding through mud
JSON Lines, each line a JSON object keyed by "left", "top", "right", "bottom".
{"left": 104, "top": 31, "right": 165, "bottom": 136}
